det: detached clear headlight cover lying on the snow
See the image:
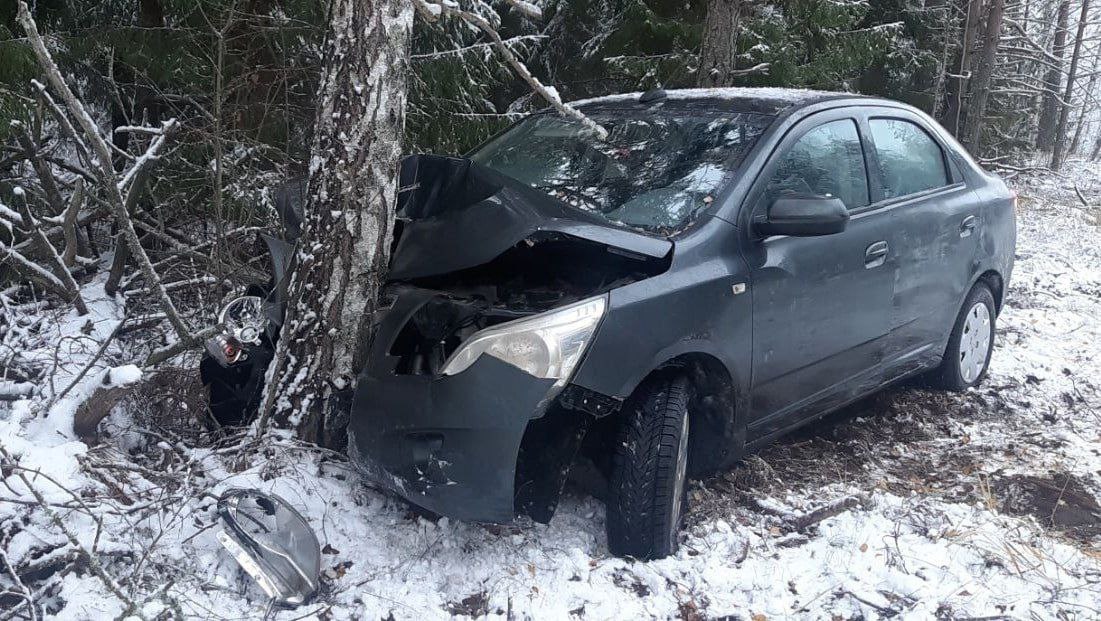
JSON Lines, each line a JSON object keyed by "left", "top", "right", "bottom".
{"left": 218, "top": 489, "right": 321, "bottom": 608}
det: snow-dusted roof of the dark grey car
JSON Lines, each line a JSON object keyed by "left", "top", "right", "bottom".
{"left": 570, "top": 87, "right": 874, "bottom": 115}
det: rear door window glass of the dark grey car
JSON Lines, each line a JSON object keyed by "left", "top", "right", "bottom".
{"left": 869, "top": 119, "right": 948, "bottom": 198}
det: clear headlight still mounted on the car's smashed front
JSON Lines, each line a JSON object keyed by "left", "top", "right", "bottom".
{"left": 443, "top": 295, "right": 607, "bottom": 381}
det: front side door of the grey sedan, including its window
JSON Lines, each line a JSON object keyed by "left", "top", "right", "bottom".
{"left": 745, "top": 109, "right": 896, "bottom": 439}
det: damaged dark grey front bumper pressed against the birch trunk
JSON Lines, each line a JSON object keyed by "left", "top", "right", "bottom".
{"left": 348, "top": 290, "right": 576, "bottom": 523}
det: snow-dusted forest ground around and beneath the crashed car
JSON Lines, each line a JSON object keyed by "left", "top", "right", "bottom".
{"left": 0, "top": 168, "right": 1101, "bottom": 621}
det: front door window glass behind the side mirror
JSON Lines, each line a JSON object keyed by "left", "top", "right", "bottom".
{"left": 764, "top": 119, "right": 868, "bottom": 209}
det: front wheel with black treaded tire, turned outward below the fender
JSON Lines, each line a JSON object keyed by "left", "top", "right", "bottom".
{"left": 607, "top": 371, "right": 691, "bottom": 559}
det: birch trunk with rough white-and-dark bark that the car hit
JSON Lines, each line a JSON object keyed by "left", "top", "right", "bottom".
{"left": 260, "top": 0, "right": 413, "bottom": 446}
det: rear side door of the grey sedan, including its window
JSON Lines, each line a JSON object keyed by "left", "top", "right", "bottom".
{"left": 865, "top": 108, "right": 982, "bottom": 375}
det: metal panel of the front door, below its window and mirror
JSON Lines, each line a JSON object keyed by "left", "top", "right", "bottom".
{"left": 749, "top": 213, "right": 897, "bottom": 436}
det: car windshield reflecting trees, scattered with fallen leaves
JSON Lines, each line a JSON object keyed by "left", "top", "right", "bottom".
{"left": 471, "top": 110, "right": 772, "bottom": 235}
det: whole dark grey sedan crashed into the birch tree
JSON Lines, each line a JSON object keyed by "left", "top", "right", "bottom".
{"left": 204, "top": 89, "right": 1015, "bottom": 558}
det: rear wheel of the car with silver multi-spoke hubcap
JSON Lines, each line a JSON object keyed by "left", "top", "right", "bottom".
{"left": 931, "top": 283, "right": 995, "bottom": 391}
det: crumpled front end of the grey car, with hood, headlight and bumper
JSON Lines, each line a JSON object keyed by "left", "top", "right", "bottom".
{"left": 349, "top": 153, "right": 672, "bottom": 522}
